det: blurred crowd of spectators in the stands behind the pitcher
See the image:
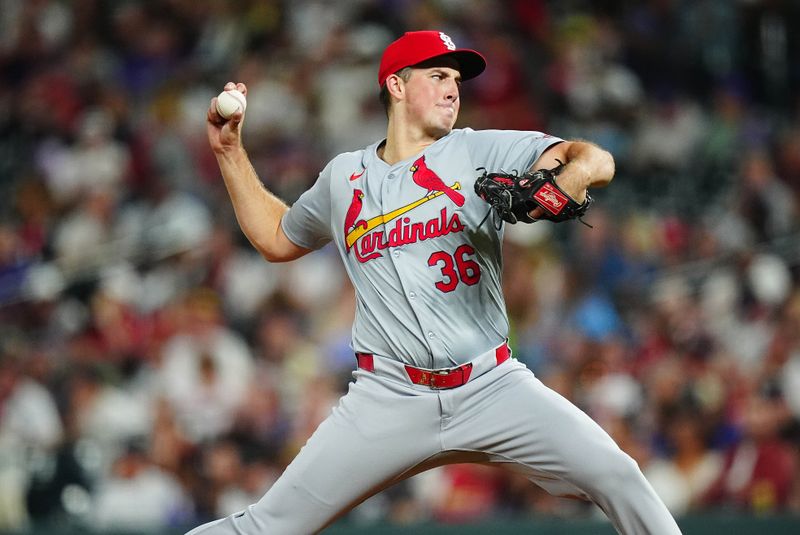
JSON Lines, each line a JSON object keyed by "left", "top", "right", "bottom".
{"left": 0, "top": 0, "right": 800, "bottom": 531}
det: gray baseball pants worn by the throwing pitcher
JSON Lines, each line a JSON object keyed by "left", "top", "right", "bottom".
{"left": 188, "top": 357, "right": 680, "bottom": 535}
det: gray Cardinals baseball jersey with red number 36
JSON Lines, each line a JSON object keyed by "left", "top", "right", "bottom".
{"left": 283, "top": 128, "right": 561, "bottom": 368}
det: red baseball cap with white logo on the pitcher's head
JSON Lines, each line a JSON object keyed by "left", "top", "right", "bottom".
{"left": 378, "top": 30, "right": 486, "bottom": 86}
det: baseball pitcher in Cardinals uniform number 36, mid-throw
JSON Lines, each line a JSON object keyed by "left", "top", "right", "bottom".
{"left": 190, "top": 31, "right": 680, "bottom": 535}
